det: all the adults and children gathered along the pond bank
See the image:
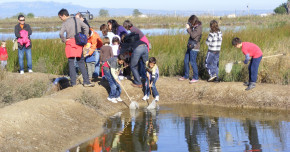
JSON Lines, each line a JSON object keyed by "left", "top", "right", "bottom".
{"left": 0, "top": 9, "right": 262, "bottom": 103}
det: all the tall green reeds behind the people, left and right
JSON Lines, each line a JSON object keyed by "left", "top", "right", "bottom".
{"left": 2, "top": 22, "right": 290, "bottom": 84}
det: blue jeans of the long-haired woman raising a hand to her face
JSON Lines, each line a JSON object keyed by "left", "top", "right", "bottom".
{"left": 183, "top": 49, "right": 198, "bottom": 80}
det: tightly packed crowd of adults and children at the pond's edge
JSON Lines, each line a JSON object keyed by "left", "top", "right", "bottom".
{"left": 58, "top": 9, "right": 159, "bottom": 103}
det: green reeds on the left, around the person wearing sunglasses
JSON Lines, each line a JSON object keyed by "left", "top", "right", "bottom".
{"left": 7, "top": 39, "right": 68, "bottom": 75}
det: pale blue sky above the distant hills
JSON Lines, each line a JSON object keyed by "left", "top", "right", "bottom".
{"left": 0, "top": 0, "right": 287, "bottom": 11}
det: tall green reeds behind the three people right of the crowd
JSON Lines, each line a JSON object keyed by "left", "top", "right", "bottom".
{"left": 149, "top": 24, "right": 290, "bottom": 84}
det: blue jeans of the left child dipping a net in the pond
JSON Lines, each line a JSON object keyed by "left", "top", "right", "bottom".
{"left": 104, "top": 67, "right": 121, "bottom": 98}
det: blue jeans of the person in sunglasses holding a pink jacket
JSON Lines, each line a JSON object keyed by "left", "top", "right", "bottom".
{"left": 18, "top": 47, "right": 32, "bottom": 71}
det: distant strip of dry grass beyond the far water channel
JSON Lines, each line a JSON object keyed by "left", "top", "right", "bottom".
{"left": 0, "top": 14, "right": 290, "bottom": 32}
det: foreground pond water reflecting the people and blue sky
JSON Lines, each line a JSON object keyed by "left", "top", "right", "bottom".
{"left": 67, "top": 105, "right": 290, "bottom": 152}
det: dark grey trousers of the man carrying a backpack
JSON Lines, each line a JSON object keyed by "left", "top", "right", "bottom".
{"left": 68, "top": 55, "right": 90, "bottom": 86}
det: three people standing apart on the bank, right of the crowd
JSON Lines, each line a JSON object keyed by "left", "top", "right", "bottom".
{"left": 179, "top": 15, "right": 263, "bottom": 90}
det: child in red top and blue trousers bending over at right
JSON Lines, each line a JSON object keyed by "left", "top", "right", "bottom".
{"left": 232, "top": 37, "right": 263, "bottom": 90}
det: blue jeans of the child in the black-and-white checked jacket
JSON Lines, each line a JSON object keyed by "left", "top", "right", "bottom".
{"left": 205, "top": 51, "right": 220, "bottom": 77}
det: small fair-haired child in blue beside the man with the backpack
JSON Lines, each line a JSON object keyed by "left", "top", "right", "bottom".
{"left": 83, "top": 43, "right": 96, "bottom": 80}
